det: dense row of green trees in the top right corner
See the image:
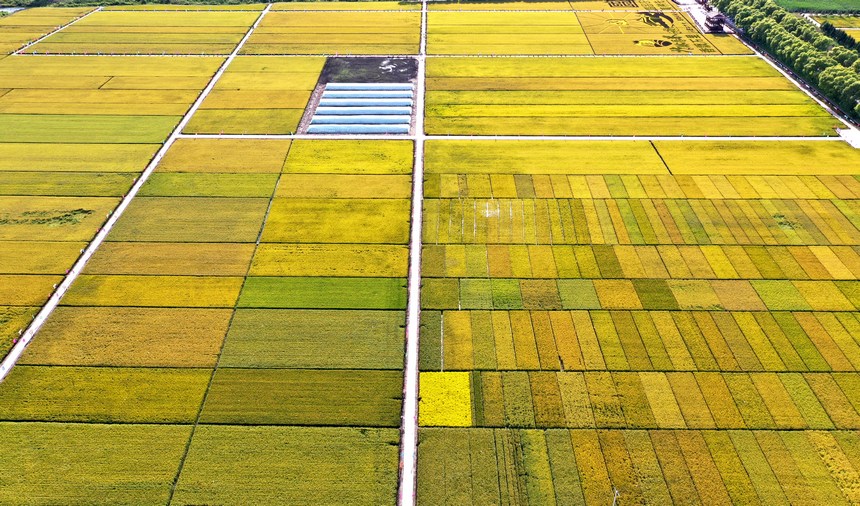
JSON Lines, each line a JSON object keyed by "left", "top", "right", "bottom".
{"left": 714, "top": 0, "right": 860, "bottom": 119}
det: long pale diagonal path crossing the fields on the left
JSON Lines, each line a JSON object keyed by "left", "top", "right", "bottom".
{"left": 0, "top": 4, "right": 272, "bottom": 382}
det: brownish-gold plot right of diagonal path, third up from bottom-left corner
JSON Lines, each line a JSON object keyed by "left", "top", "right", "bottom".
{"left": 20, "top": 307, "right": 231, "bottom": 367}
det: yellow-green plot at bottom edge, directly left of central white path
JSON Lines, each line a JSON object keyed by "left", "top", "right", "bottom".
{"left": 174, "top": 425, "right": 399, "bottom": 504}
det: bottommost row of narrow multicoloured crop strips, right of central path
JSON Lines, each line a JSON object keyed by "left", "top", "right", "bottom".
{"left": 418, "top": 429, "right": 858, "bottom": 505}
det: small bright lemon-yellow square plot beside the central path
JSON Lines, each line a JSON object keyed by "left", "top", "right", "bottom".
{"left": 418, "top": 372, "right": 472, "bottom": 427}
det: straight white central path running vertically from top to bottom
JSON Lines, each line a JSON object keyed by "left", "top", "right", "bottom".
{"left": 397, "top": 0, "right": 427, "bottom": 506}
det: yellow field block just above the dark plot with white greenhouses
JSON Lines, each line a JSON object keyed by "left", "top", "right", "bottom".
{"left": 242, "top": 11, "right": 421, "bottom": 55}
